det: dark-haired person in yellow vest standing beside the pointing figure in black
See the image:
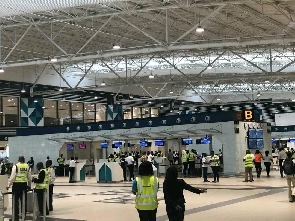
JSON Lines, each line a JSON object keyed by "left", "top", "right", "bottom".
{"left": 132, "top": 161, "right": 159, "bottom": 221}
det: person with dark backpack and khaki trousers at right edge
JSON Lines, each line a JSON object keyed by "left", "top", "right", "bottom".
{"left": 283, "top": 152, "right": 295, "bottom": 202}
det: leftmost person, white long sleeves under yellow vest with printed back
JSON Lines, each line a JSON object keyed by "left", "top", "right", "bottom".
{"left": 6, "top": 156, "right": 32, "bottom": 220}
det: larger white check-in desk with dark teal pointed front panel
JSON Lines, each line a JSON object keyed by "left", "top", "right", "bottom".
{"left": 95, "top": 160, "right": 123, "bottom": 182}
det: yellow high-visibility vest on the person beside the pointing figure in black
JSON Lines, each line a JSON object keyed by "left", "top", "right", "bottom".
{"left": 135, "top": 176, "right": 159, "bottom": 210}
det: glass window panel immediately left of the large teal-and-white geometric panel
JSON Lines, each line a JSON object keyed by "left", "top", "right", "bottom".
{"left": 3, "top": 97, "right": 19, "bottom": 127}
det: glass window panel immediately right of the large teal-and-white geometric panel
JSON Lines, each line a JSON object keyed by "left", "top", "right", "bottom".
{"left": 44, "top": 100, "right": 59, "bottom": 126}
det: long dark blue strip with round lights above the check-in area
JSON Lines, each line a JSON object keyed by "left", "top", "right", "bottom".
{"left": 16, "top": 111, "right": 252, "bottom": 136}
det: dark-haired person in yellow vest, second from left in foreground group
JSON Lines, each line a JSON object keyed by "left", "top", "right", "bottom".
{"left": 33, "top": 162, "right": 49, "bottom": 216}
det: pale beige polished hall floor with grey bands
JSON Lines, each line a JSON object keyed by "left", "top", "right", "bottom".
{"left": 7, "top": 172, "right": 295, "bottom": 221}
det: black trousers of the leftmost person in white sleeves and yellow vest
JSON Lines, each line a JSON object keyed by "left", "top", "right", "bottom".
{"left": 12, "top": 183, "right": 27, "bottom": 220}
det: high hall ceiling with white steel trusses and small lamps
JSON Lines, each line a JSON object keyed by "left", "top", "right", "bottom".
{"left": 0, "top": 0, "right": 295, "bottom": 104}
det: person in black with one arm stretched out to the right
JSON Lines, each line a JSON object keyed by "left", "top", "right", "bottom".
{"left": 163, "top": 167, "right": 207, "bottom": 221}
